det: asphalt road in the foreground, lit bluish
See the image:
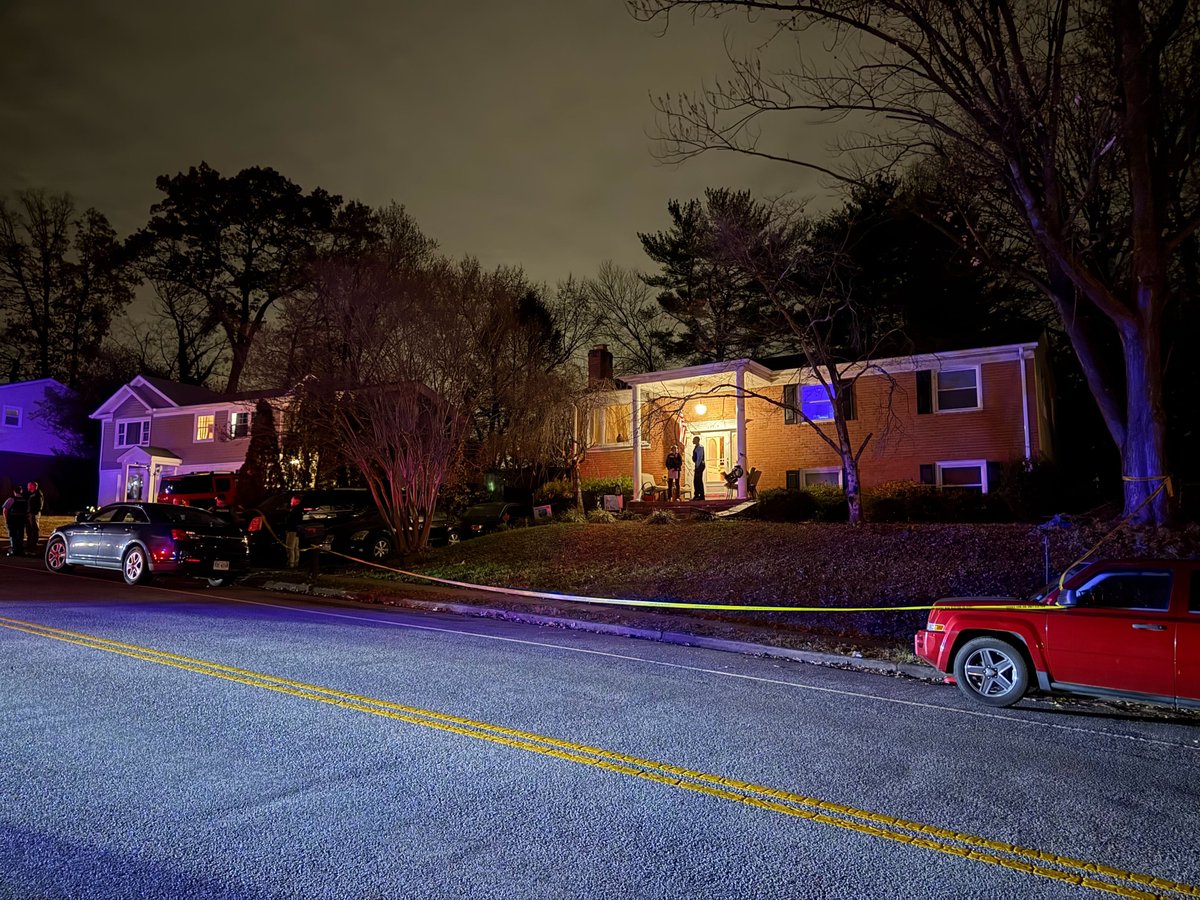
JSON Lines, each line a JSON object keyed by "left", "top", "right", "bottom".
{"left": 0, "top": 560, "right": 1200, "bottom": 900}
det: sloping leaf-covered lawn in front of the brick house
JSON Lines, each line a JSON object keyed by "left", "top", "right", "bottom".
{"left": 336, "top": 521, "right": 1200, "bottom": 648}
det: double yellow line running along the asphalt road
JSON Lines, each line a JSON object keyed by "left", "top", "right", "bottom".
{"left": 0, "top": 617, "right": 1200, "bottom": 898}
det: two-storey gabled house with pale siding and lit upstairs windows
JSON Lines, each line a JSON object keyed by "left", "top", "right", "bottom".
{"left": 91, "top": 376, "right": 287, "bottom": 505}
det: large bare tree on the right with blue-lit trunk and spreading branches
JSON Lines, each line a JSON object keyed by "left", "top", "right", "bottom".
{"left": 629, "top": 0, "right": 1200, "bottom": 523}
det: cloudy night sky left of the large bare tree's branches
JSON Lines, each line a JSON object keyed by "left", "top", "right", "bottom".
{"left": 0, "top": 0, "right": 835, "bottom": 284}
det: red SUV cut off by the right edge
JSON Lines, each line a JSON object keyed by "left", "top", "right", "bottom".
{"left": 914, "top": 559, "right": 1200, "bottom": 708}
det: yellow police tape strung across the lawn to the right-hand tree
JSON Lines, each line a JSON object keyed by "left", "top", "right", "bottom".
{"left": 251, "top": 475, "right": 1172, "bottom": 613}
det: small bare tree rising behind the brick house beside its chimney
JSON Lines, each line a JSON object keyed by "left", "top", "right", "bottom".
{"left": 583, "top": 260, "right": 672, "bottom": 372}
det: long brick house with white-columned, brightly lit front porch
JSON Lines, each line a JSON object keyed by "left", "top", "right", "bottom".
{"left": 581, "top": 342, "right": 1054, "bottom": 498}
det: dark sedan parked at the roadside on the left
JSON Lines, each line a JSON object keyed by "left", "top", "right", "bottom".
{"left": 46, "top": 503, "right": 250, "bottom": 587}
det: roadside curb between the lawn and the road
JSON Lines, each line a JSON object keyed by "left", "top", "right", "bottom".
{"left": 262, "top": 581, "right": 946, "bottom": 683}
